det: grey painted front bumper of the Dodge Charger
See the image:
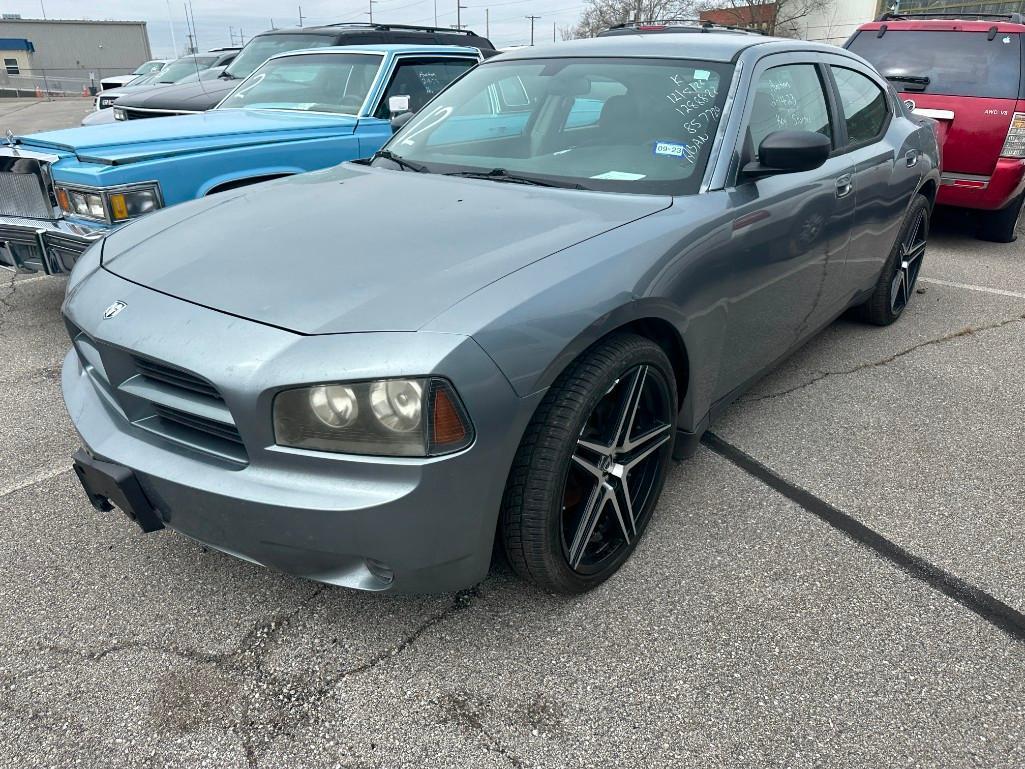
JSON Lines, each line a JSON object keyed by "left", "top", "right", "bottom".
{"left": 62, "top": 275, "right": 541, "bottom": 593}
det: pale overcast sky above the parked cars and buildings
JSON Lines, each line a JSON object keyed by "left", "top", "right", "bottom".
{"left": 0, "top": 0, "right": 584, "bottom": 57}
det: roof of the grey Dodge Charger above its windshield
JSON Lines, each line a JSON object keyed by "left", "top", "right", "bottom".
{"left": 490, "top": 32, "right": 847, "bottom": 62}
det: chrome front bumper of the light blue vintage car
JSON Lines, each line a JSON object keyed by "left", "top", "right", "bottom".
{"left": 0, "top": 216, "right": 108, "bottom": 275}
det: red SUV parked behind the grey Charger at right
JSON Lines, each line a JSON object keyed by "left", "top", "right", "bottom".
{"left": 844, "top": 13, "right": 1025, "bottom": 243}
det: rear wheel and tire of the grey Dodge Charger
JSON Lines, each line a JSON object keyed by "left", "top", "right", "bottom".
{"left": 858, "top": 195, "right": 932, "bottom": 326}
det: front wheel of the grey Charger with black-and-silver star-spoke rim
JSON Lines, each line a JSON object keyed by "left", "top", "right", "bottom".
{"left": 499, "top": 333, "right": 678, "bottom": 594}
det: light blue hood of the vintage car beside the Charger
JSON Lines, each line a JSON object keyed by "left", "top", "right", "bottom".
{"left": 22, "top": 110, "right": 357, "bottom": 165}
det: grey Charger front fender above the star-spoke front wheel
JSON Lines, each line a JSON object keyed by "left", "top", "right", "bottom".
{"left": 424, "top": 198, "right": 732, "bottom": 430}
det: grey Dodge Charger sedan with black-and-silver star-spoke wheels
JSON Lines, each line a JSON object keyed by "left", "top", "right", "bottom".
{"left": 63, "top": 33, "right": 939, "bottom": 593}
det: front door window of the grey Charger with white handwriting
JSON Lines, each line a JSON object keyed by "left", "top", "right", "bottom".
{"left": 747, "top": 65, "right": 832, "bottom": 154}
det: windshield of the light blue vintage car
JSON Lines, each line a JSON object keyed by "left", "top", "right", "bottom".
{"left": 217, "top": 53, "right": 381, "bottom": 115}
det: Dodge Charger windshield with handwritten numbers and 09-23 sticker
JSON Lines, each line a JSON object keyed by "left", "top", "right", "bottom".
{"left": 383, "top": 58, "right": 732, "bottom": 195}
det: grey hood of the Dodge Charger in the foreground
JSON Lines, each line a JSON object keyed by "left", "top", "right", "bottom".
{"left": 103, "top": 163, "right": 672, "bottom": 334}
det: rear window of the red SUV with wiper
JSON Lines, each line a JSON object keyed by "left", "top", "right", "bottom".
{"left": 847, "top": 30, "right": 1022, "bottom": 98}
